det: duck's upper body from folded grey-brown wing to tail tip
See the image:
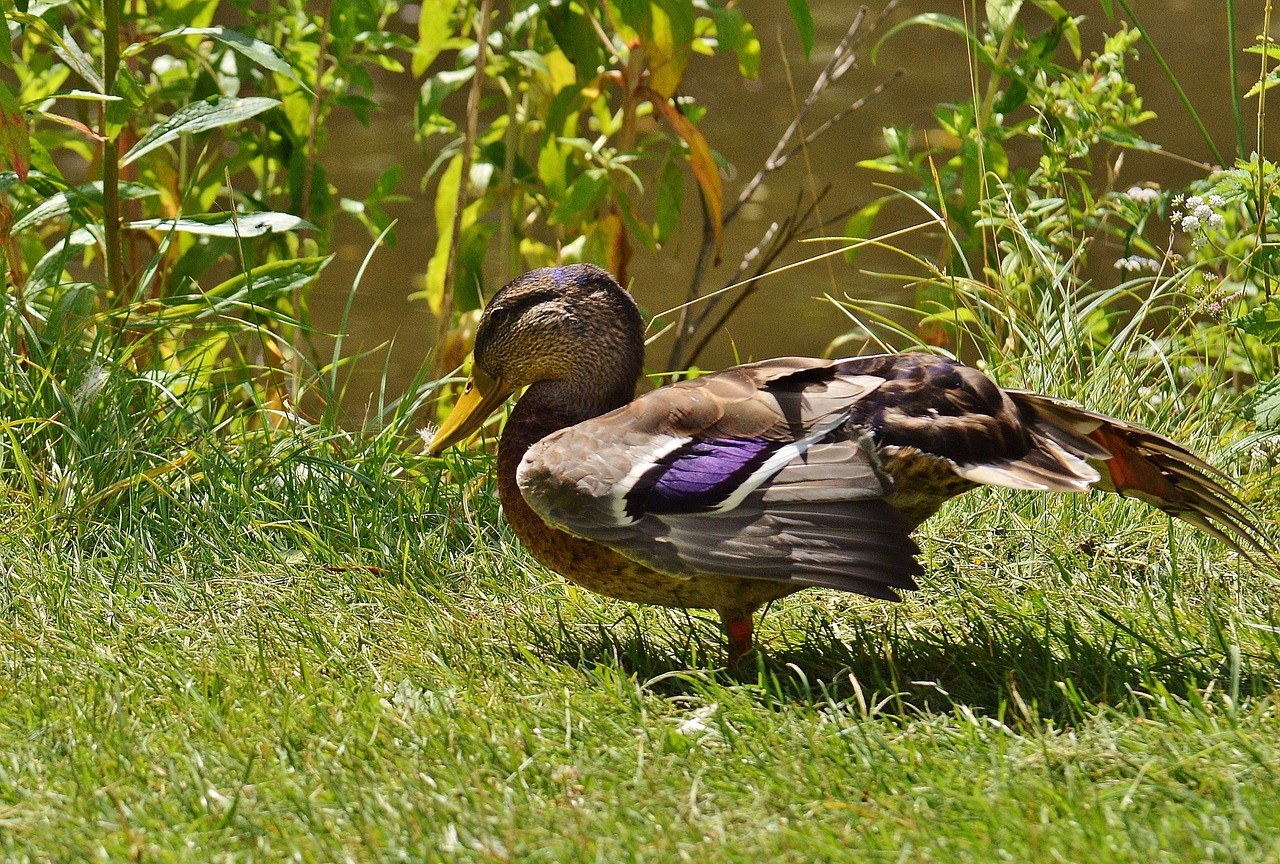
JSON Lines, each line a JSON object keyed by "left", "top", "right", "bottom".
{"left": 517, "top": 355, "right": 1252, "bottom": 609}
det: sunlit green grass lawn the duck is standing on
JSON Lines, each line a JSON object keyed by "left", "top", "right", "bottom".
{"left": 0, "top": 394, "right": 1280, "bottom": 863}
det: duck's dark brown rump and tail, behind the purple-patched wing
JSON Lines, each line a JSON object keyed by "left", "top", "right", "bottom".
{"left": 845, "top": 355, "right": 1272, "bottom": 558}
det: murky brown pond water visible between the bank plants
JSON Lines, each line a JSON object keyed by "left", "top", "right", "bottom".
{"left": 311, "top": 0, "right": 1280, "bottom": 415}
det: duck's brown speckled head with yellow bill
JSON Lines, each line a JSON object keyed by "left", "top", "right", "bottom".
{"left": 428, "top": 264, "right": 644, "bottom": 456}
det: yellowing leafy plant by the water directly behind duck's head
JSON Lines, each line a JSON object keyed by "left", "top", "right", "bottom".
{"left": 413, "top": 0, "right": 896, "bottom": 374}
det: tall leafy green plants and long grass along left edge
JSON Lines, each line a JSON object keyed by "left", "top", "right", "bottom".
{"left": 0, "top": 0, "right": 440, "bottom": 512}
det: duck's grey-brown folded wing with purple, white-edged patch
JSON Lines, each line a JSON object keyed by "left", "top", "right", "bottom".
{"left": 517, "top": 358, "right": 922, "bottom": 598}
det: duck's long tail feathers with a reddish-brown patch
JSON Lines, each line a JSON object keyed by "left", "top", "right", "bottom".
{"left": 1010, "top": 390, "right": 1275, "bottom": 561}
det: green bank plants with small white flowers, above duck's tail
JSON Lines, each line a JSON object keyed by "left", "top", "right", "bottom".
{"left": 846, "top": 1, "right": 1280, "bottom": 445}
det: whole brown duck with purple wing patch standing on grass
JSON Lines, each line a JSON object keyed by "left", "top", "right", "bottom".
{"left": 426, "top": 264, "right": 1265, "bottom": 664}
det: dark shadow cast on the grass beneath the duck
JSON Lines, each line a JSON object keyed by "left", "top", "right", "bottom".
{"left": 530, "top": 616, "right": 1280, "bottom": 727}
